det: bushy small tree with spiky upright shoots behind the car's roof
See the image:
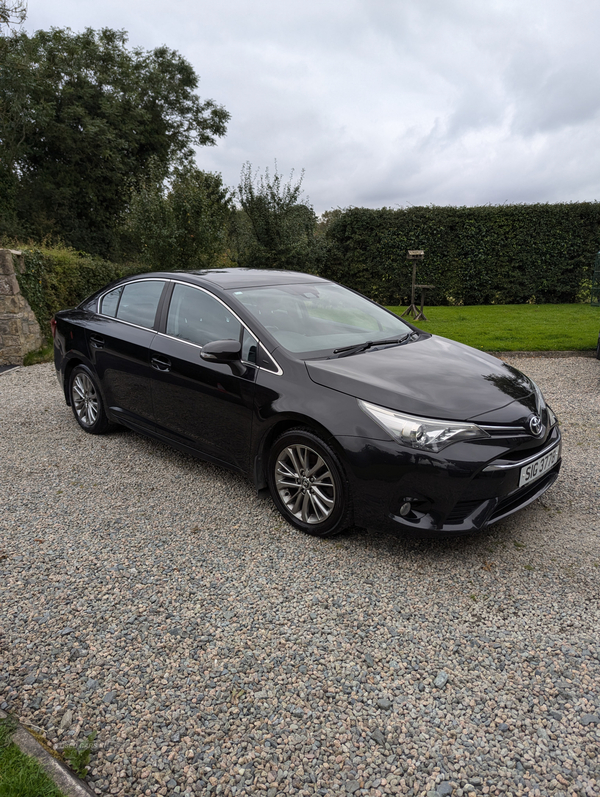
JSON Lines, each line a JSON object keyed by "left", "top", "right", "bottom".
{"left": 237, "top": 162, "right": 316, "bottom": 269}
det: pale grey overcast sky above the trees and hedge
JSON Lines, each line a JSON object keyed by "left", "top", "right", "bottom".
{"left": 25, "top": 0, "right": 600, "bottom": 213}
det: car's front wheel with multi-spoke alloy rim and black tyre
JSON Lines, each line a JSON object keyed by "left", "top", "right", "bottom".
{"left": 267, "top": 429, "right": 352, "bottom": 537}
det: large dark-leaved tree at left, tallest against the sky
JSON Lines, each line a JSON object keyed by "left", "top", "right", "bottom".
{"left": 0, "top": 28, "right": 229, "bottom": 256}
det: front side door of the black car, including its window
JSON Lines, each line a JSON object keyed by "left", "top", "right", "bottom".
{"left": 150, "top": 283, "right": 257, "bottom": 471}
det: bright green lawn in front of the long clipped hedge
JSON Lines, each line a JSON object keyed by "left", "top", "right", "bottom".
{"left": 388, "top": 304, "right": 600, "bottom": 351}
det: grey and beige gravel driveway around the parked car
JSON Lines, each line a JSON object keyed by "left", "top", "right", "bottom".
{"left": 0, "top": 357, "right": 600, "bottom": 797}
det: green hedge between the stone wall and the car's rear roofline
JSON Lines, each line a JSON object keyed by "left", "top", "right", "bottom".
{"left": 17, "top": 248, "right": 146, "bottom": 335}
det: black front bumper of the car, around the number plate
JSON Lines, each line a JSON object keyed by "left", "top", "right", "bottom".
{"left": 337, "top": 425, "right": 561, "bottom": 537}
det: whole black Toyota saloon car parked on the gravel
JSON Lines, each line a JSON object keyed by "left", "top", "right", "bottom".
{"left": 53, "top": 268, "right": 561, "bottom": 536}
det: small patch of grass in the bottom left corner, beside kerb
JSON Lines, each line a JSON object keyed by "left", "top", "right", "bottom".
{"left": 0, "top": 718, "right": 64, "bottom": 797}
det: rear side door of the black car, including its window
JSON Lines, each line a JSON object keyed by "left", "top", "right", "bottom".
{"left": 86, "top": 279, "right": 166, "bottom": 429}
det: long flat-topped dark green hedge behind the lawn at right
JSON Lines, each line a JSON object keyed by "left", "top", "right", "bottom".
{"left": 320, "top": 202, "right": 600, "bottom": 305}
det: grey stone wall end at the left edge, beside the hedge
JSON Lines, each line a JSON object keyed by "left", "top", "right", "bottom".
{"left": 0, "top": 249, "right": 43, "bottom": 365}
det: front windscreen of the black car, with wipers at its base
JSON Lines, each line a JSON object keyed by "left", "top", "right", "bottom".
{"left": 232, "top": 283, "right": 411, "bottom": 356}
